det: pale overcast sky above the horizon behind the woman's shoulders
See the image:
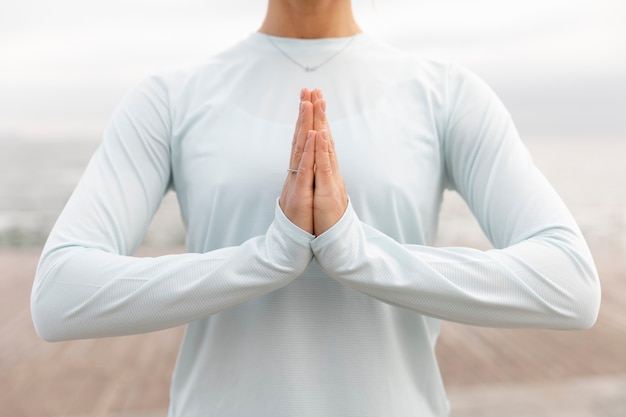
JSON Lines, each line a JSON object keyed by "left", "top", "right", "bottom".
{"left": 0, "top": 0, "right": 626, "bottom": 141}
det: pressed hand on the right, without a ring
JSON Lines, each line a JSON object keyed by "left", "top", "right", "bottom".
{"left": 312, "top": 90, "right": 348, "bottom": 236}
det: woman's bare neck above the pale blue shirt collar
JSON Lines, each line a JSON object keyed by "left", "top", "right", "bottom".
{"left": 259, "top": 0, "right": 361, "bottom": 39}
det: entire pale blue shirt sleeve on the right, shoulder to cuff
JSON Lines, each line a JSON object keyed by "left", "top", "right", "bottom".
{"left": 312, "top": 62, "right": 600, "bottom": 329}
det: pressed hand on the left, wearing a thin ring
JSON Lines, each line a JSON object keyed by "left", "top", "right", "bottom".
{"left": 279, "top": 88, "right": 315, "bottom": 234}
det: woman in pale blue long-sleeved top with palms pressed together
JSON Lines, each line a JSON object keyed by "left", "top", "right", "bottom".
{"left": 32, "top": 0, "right": 599, "bottom": 417}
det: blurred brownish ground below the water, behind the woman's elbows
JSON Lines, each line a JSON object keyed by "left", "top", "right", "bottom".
{"left": 0, "top": 250, "right": 626, "bottom": 417}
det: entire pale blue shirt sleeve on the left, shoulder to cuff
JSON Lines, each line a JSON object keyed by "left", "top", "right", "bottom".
{"left": 31, "top": 77, "right": 313, "bottom": 341}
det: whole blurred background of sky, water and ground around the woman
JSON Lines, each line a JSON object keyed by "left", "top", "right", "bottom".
{"left": 0, "top": 0, "right": 626, "bottom": 417}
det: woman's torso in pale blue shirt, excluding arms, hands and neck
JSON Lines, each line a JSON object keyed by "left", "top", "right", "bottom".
{"left": 170, "top": 34, "right": 447, "bottom": 416}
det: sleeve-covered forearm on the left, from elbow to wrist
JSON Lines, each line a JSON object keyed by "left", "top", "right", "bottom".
{"left": 31, "top": 202, "right": 312, "bottom": 341}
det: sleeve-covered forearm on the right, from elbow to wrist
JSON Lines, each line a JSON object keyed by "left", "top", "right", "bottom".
{"left": 312, "top": 203, "right": 599, "bottom": 329}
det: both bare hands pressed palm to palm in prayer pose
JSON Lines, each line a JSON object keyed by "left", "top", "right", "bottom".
{"left": 280, "top": 88, "right": 348, "bottom": 236}
